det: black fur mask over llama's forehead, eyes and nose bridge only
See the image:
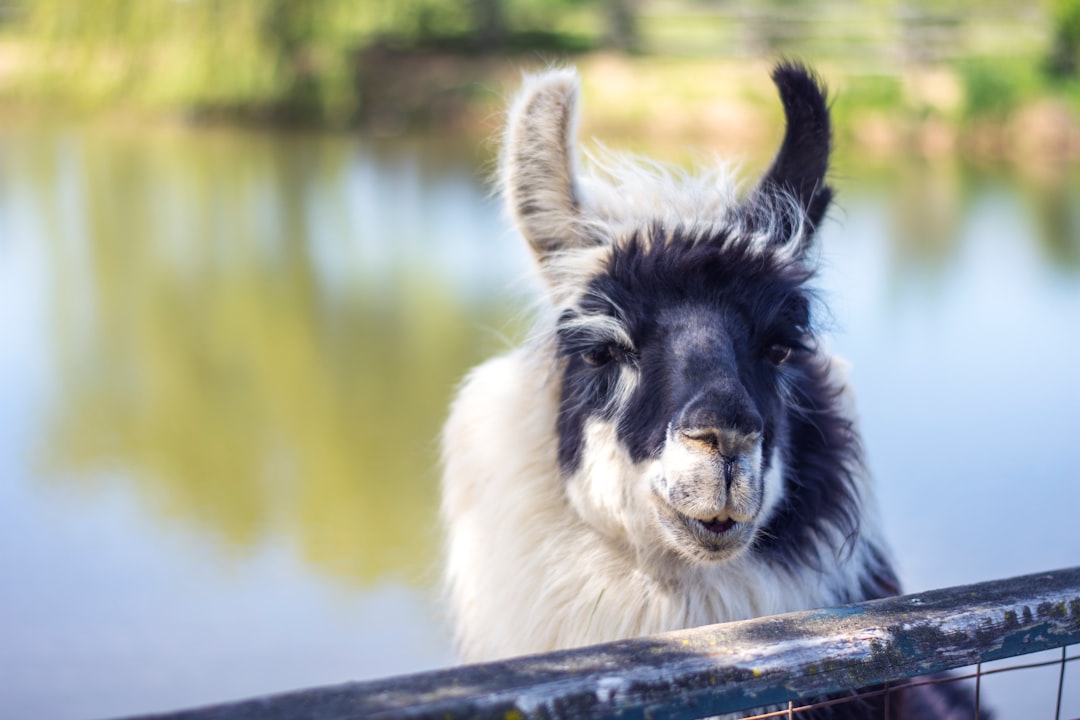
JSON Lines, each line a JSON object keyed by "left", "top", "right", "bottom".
{"left": 558, "top": 229, "right": 809, "bottom": 472}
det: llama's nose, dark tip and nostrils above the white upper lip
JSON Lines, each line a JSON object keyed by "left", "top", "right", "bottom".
{"left": 672, "top": 389, "right": 765, "bottom": 457}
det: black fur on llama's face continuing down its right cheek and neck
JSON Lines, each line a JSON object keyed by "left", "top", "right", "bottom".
{"left": 558, "top": 229, "right": 872, "bottom": 569}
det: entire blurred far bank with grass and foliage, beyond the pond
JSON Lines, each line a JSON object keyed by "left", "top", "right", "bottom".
{"left": 0, "top": 0, "right": 1080, "bottom": 162}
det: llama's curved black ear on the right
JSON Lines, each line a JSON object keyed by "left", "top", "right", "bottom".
{"left": 746, "top": 62, "right": 833, "bottom": 252}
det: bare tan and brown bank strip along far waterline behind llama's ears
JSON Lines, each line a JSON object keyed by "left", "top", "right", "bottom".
{"left": 349, "top": 52, "right": 1080, "bottom": 162}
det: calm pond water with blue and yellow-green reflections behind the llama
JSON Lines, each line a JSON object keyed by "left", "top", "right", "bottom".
{"left": 0, "top": 127, "right": 1080, "bottom": 718}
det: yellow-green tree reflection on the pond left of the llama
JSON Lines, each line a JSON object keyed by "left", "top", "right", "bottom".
{"left": 13, "top": 124, "right": 527, "bottom": 582}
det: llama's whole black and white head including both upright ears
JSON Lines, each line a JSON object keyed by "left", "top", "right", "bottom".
{"left": 501, "top": 64, "right": 832, "bottom": 562}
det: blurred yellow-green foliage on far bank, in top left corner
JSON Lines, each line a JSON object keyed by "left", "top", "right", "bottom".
{"left": 10, "top": 0, "right": 362, "bottom": 118}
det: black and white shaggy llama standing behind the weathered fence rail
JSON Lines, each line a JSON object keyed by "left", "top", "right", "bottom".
{"left": 442, "top": 63, "right": 980, "bottom": 717}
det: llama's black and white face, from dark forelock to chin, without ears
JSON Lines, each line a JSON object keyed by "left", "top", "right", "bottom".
{"left": 556, "top": 232, "right": 810, "bottom": 561}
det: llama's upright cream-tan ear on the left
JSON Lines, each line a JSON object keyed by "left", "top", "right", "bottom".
{"left": 499, "top": 69, "right": 585, "bottom": 261}
